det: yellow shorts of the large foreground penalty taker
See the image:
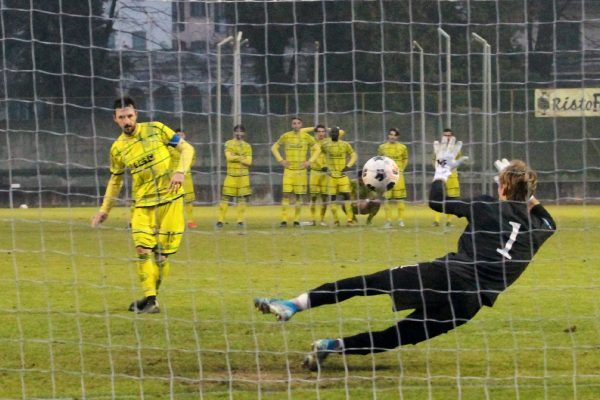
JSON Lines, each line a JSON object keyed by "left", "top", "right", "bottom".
{"left": 131, "top": 196, "right": 185, "bottom": 254}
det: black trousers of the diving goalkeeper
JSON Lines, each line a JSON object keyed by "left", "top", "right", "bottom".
{"left": 308, "top": 263, "right": 481, "bottom": 354}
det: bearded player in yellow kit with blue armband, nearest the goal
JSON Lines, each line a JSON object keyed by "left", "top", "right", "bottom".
{"left": 92, "top": 97, "right": 195, "bottom": 313}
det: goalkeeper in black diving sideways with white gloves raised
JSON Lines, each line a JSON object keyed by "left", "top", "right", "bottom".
{"left": 254, "top": 138, "right": 556, "bottom": 370}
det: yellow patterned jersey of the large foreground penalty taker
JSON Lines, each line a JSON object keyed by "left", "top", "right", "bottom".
{"left": 110, "top": 122, "right": 183, "bottom": 207}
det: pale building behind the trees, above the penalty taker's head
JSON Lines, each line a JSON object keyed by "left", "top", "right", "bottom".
{"left": 105, "top": 0, "right": 256, "bottom": 120}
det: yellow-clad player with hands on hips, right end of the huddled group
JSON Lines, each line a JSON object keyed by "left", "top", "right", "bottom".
{"left": 321, "top": 127, "right": 357, "bottom": 226}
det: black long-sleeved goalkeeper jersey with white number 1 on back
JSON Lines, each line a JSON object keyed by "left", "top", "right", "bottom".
{"left": 429, "top": 180, "right": 556, "bottom": 306}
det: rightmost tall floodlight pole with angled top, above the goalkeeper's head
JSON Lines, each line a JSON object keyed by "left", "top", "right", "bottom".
{"left": 471, "top": 33, "right": 492, "bottom": 193}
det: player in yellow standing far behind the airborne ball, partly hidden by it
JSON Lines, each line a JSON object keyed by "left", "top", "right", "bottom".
{"left": 377, "top": 128, "right": 408, "bottom": 228}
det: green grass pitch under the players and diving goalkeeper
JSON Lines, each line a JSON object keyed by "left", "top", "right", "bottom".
{"left": 0, "top": 206, "right": 600, "bottom": 399}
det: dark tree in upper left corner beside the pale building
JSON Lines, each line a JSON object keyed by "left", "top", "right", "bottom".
{"left": 1, "top": 0, "right": 119, "bottom": 111}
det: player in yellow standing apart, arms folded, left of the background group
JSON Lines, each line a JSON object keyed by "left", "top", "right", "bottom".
{"left": 216, "top": 125, "right": 252, "bottom": 229}
